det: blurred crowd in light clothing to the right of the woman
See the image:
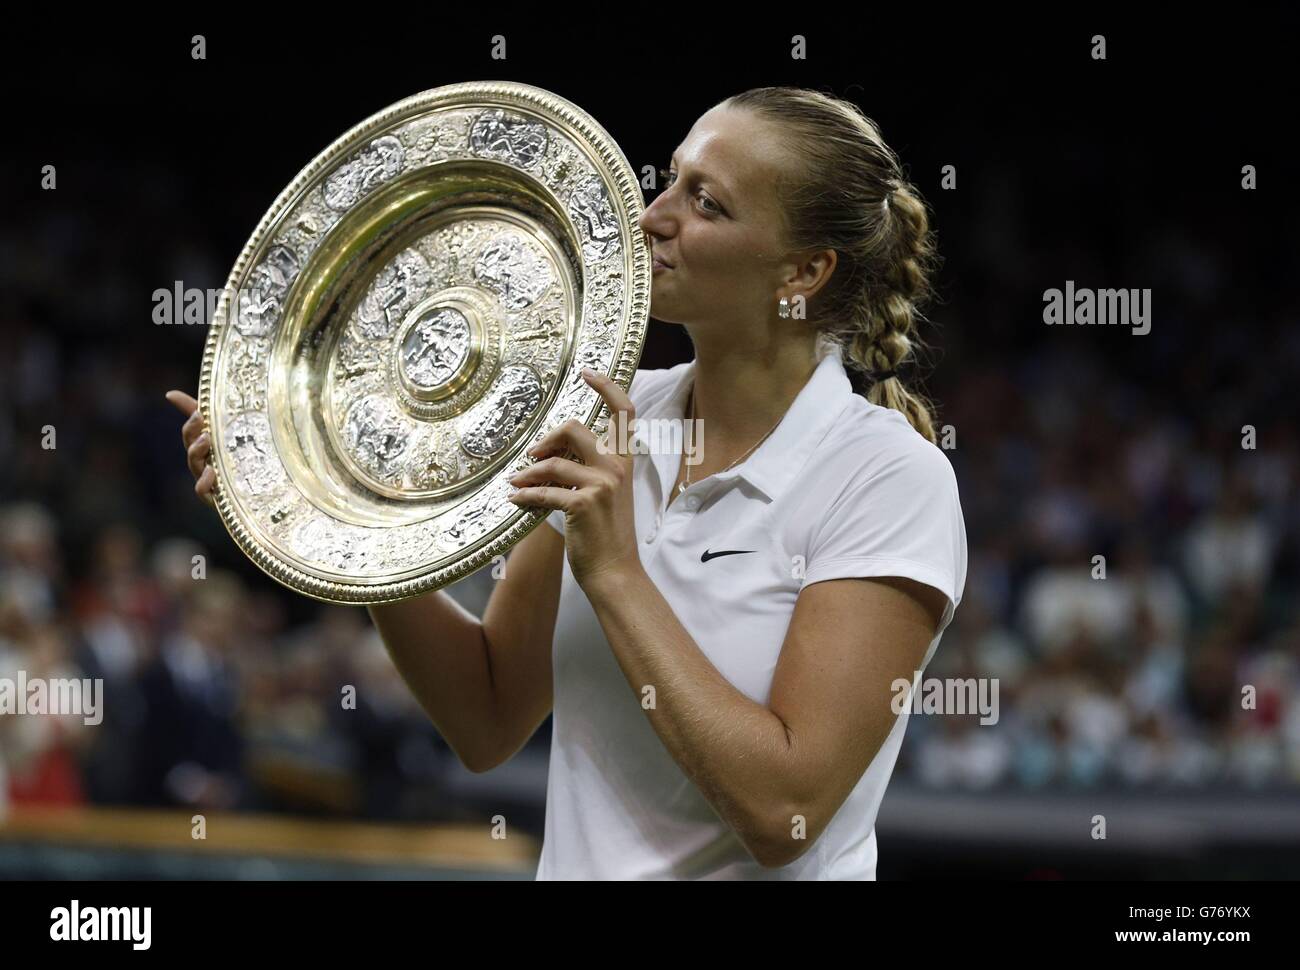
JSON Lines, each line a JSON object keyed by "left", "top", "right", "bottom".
{"left": 900, "top": 441, "right": 1300, "bottom": 789}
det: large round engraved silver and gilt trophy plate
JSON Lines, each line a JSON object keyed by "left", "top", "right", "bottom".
{"left": 199, "top": 82, "right": 650, "bottom": 603}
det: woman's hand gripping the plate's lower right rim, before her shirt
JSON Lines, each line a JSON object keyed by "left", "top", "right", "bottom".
{"left": 510, "top": 371, "right": 641, "bottom": 589}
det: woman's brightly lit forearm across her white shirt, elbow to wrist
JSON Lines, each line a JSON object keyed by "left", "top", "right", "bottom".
{"left": 585, "top": 570, "right": 793, "bottom": 857}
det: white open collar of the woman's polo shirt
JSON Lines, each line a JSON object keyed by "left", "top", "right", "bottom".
{"left": 638, "top": 338, "right": 853, "bottom": 501}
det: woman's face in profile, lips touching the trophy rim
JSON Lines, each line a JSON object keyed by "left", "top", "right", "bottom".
{"left": 641, "top": 107, "right": 796, "bottom": 329}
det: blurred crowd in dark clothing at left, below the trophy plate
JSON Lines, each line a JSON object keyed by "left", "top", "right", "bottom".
{"left": 0, "top": 502, "right": 488, "bottom": 819}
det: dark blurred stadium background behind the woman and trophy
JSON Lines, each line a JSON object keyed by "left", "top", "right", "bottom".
{"left": 0, "top": 7, "right": 1300, "bottom": 878}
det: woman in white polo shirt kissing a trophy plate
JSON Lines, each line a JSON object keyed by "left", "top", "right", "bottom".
{"left": 170, "top": 88, "right": 966, "bottom": 879}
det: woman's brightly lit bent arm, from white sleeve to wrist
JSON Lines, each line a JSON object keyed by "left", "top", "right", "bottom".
{"left": 586, "top": 570, "right": 946, "bottom": 867}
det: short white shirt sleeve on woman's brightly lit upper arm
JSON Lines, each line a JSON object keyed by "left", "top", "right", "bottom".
{"left": 803, "top": 441, "right": 966, "bottom": 623}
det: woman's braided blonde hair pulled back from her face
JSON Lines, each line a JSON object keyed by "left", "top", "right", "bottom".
{"left": 722, "top": 86, "right": 941, "bottom": 445}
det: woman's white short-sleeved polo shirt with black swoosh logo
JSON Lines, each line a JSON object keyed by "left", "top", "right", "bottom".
{"left": 537, "top": 342, "right": 966, "bottom": 879}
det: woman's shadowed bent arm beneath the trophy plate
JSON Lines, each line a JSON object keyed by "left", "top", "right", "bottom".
{"left": 368, "top": 523, "right": 564, "bottom": 772}
